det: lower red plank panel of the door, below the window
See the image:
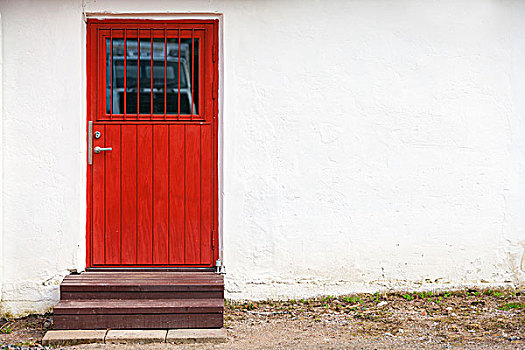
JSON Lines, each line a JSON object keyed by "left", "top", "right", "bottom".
{"left": 93, "top": 124, "right": 213, "bottom": 266}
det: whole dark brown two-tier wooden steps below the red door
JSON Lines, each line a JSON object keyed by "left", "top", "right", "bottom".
{"left": 53, "top": 272, "right": 224, "bottom": 329}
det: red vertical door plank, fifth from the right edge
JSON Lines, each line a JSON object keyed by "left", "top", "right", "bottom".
{"left": 136, "top": 125, "right": 153, "bottom": 264}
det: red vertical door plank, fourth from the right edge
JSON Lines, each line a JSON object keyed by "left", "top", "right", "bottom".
{"left": 153, "top": 125, "right": 168, "bottom": 264}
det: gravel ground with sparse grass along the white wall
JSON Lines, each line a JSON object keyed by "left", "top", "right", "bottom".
{"left": 0, "top": 290, "right": 525, "bottom": 350}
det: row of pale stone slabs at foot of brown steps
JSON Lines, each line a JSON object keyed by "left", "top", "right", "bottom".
{"left": 42, "top": 328, "right": 227, "bottom": 346}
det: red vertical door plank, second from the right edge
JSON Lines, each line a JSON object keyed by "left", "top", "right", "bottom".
{"left": 184, "top": 125, "right": 201, "bottom": 264}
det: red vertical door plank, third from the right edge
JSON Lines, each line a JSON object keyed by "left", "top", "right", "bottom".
{"left": 169, "top": 125, "right": 185, "bottom": 264}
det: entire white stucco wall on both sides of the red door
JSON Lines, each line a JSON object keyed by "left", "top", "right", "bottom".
{"left": 0, "top": 0, "right": 525, "bottom": 314}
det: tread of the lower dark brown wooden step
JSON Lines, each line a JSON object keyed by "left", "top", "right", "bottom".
{"left": 54, "top": 299, "right": 224, "bottom": 315}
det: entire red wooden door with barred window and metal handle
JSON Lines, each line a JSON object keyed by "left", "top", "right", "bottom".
{"left": 87, "top": 20, "right": 218, "bottom": 267}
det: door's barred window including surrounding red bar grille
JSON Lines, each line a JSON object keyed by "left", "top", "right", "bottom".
{"left": 98, "top": 29, "right": 207, "bottom": 120}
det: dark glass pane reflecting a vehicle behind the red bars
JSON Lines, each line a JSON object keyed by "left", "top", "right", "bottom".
{"left": 106, "top": 38, "right": 199, "bottom": 115}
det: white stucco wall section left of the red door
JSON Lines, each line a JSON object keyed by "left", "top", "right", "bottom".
{"left": 0, "top": 0, "right": 86, "bottom": 314}
